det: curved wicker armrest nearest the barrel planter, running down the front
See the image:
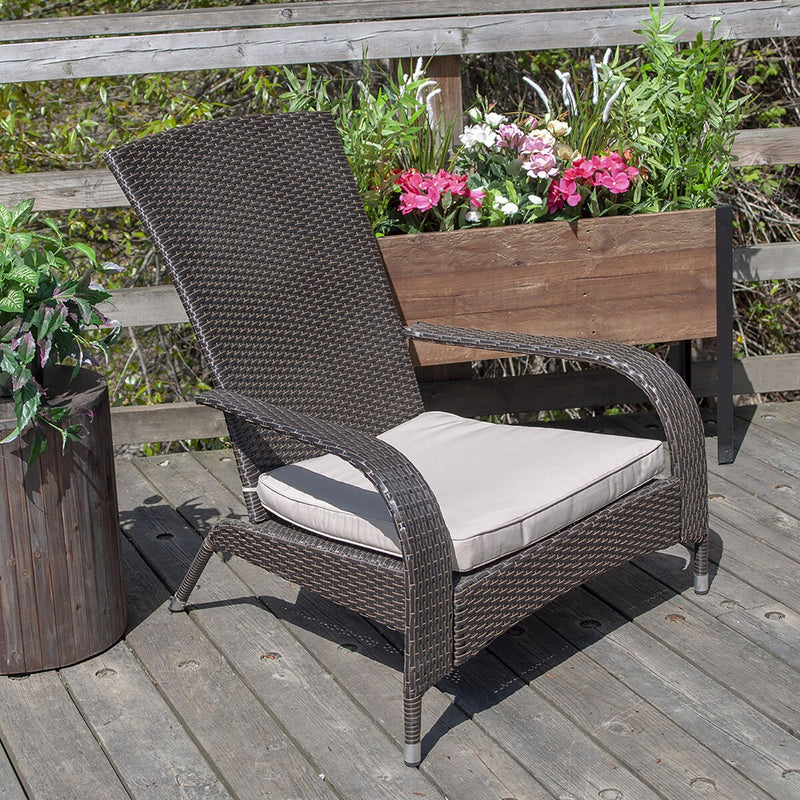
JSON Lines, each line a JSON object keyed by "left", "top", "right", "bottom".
{"left": 195, "top": 389, "right": 453, "bottom": 686}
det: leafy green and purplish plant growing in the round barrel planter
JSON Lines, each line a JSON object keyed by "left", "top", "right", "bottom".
{"left": 0, "top": 200, "right": 119, "bottom": 459}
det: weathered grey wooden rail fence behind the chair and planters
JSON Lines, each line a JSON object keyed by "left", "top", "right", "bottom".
{"left": 0, "top": 0, "right": 800, "bottom": 444}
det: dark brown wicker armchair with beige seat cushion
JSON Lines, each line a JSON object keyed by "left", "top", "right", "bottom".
{"left": 106, "top": 114, "right": 708, "bottom": 765}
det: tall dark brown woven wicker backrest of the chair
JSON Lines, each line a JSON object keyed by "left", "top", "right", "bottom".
{"left": 106, "top": 113, "right": 422, "bottom": 512}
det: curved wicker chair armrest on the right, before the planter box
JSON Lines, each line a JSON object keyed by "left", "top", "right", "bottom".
{"left": 405, "top": 322, "right": 708, "bottom": 541}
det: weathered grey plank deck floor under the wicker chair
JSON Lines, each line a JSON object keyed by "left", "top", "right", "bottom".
{"left": 0, "top": 403, "right": 800, "bottom": 800}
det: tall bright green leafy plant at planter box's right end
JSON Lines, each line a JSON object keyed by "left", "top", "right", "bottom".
{"left": 615, "top": 5, "right": 748, "bottom": 211}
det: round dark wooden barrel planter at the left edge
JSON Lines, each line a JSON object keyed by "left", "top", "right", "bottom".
{"left": 0, "top": 367, "right": 125, "bottom": 675}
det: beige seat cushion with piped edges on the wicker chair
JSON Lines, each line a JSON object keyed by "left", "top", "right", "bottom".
{"left": 257, "top": 411, "right": 664, "bottom": 572}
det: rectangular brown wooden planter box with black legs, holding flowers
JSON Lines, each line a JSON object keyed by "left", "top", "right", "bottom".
{"left": 378, "top": 208, "right": 733, "bottom": 463}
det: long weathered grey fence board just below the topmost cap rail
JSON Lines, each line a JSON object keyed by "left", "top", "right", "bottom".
{"left": 0, "top": 0, "right": 800, "bottom": 83}
